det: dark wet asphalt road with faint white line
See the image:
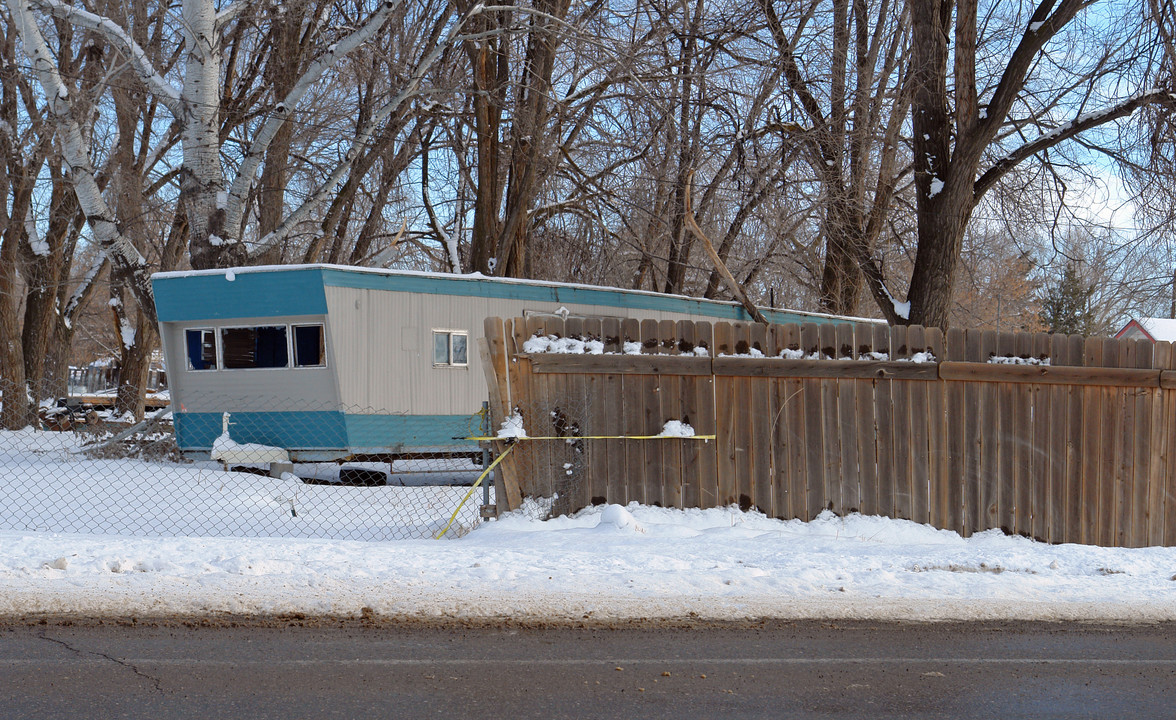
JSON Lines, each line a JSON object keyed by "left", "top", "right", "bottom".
{"left": 0, "top": 621, "right": 1176, "bottom": 720}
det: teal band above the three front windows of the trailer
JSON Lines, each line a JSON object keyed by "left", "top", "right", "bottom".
{"left": 152, "top": 267, "right": 327, "bottom": 322}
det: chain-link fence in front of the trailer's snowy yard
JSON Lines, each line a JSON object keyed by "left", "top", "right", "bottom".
{"left": 0, "top": 383, "right": 495, "bottom": 540}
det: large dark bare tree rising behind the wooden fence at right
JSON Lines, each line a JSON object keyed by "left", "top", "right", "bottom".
{"left": 904, "top": 0, "right": 1172, "bottom": 327}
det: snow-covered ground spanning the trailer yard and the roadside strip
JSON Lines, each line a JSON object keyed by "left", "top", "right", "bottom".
{"left": 0, "top": 433, "right": 1176, "bottom": 622}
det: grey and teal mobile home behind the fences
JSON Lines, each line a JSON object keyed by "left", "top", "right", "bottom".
{"left": 153, "top": 265, "right": 856, "bottom": 460}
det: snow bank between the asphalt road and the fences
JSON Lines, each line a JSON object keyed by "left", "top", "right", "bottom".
{"left": 0, "top": 505, "right": 1176, "bottom": 625}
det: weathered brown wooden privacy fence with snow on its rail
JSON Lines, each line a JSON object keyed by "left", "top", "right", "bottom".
{"left": 482, "top": 318, "right": 1176, "bottom": 547}
